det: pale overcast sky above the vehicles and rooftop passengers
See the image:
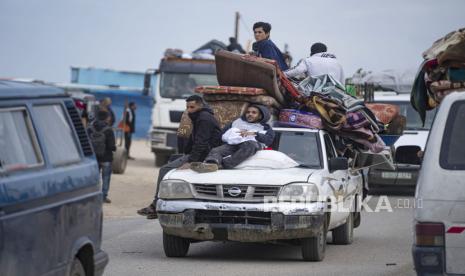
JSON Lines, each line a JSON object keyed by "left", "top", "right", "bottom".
{"left": 0, "top": 0, "right": 465, "bottom": 82}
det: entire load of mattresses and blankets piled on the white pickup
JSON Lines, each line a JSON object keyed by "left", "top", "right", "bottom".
{"left": 178, "top": 51, "right": 396, "bottom": 163}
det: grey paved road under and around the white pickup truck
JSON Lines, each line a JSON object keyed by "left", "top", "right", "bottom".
{"left": 103, "top": 196, "right": 415, "bottom": 276}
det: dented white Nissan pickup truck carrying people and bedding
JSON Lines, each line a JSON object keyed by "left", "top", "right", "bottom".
{"left": 157, "top": 128, "right": 363, "bottom": 261}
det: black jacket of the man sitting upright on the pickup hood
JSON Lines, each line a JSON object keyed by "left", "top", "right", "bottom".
{"left": 184, "top": 107, "right": 221, "bottom": 162}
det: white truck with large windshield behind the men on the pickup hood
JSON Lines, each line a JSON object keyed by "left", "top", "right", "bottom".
{"left": 150, "top": 57, "right": 218, "bottom": 166}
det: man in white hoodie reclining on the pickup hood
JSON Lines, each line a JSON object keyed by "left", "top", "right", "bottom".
{"left": 191, "top": 104, "right": 275, "bottom": 173}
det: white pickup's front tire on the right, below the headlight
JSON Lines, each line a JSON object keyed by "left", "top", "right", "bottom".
{"left": 301, "top": 216, "right": 328, "bottom": 262}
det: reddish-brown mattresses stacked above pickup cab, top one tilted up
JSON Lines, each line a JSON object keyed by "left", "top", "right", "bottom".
{"left": 178, "top": 50, "right": 286, "bottom": 138}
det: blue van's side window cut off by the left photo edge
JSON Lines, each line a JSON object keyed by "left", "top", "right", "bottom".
{"left": 0, "top": 108, "right": 43, "bottom": 172}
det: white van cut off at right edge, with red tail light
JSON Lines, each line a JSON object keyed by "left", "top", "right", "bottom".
{"left": 413, "top": 93, "right": 465, "bottom": 275}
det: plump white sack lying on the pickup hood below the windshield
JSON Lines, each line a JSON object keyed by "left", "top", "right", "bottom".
{"left": 235, "top": 150, "right": 299, "bottom": 170}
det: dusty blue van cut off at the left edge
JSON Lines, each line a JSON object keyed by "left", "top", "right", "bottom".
{"left": 0, "top": 80, "right": 108, "bottom": 276}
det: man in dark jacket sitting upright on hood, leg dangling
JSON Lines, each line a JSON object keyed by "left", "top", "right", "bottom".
{"left": 137, "top": 95, "right": 221, "bottom": 219}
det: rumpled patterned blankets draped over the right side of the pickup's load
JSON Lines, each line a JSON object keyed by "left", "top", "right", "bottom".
{"left": 280, "top": 75, "right": 385, "bottom": 153}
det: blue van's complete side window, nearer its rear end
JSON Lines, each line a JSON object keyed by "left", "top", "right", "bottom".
{"left": 34, "top": 104, "right": 80, "bottom": 165}
